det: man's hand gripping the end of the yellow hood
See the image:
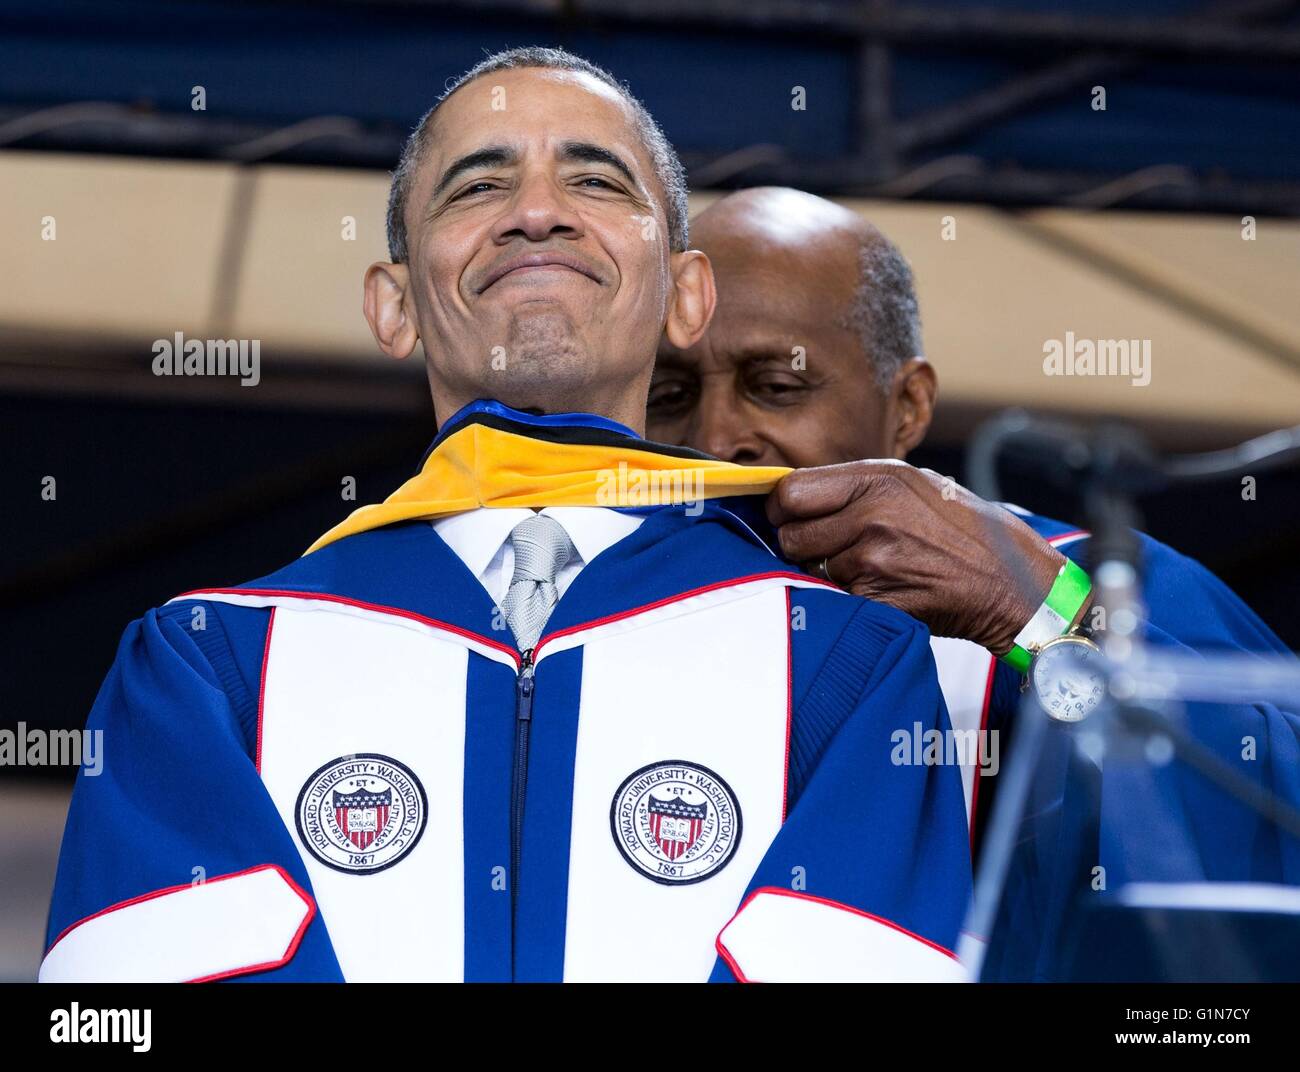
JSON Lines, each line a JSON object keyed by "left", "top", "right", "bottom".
{"left": 767, "top": 460, "right": 1065, "bottom": 655}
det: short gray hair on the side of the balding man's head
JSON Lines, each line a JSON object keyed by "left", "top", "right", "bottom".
{"left": 846, "top": 235, "right": 922, "bottom": 391}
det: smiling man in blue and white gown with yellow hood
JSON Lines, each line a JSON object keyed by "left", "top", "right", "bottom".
{"left": 42, "top": 49, "right": 970, "bottom": 981}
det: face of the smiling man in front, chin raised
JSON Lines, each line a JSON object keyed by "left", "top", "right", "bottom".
{"left": 406, "top": 70, "right": 671, "bottom": 420}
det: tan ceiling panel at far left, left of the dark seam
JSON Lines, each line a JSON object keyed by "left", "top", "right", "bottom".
{"left": 0, "top": 152, "right": 234, "bottom": 337}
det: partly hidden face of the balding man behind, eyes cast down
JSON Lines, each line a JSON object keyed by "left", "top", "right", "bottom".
{"left": 646, "top": 230, "right": 893, "bottom": 468}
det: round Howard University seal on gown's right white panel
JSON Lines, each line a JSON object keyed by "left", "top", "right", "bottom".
{"left": 610, "top": 759, "right": 741, "bottom": 886}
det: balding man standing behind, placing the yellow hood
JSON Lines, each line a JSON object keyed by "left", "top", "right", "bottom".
{"left": 647, "top": 188, "right": 1300, "bottom": 977}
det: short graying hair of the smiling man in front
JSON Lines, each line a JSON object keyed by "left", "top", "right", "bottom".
{"left": 389, "top": 47, "right": 688, "bottom": 264}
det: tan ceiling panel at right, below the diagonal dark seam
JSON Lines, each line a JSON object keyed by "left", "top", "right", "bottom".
{"left": 826, "top": 201, "right": 1300, "bottom": 425}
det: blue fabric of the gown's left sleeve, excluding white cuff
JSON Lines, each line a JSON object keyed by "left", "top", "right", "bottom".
{"left": 46, "top": 604, "right": 342, "bottom": 981}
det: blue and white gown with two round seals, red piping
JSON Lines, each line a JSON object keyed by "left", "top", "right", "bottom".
{"left": 42, "top": 415, "right": 971, "bottom": 981}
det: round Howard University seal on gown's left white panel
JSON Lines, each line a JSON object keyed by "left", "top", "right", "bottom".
{"left": 294, "top": 752, "right": 429, "bottom": 874}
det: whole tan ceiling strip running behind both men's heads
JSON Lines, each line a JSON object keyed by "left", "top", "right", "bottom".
{"left": 0, "top": 152, "right": 1300, "bottom": 428}
